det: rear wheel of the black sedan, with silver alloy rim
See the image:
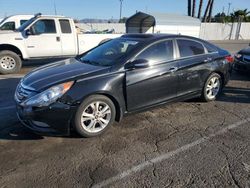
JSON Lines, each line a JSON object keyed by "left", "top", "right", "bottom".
{"left": 201, "top": 73, "right": 223, "bottom": 102}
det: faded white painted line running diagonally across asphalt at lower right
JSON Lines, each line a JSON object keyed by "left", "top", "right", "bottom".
{"left": 93, "top": 118, "right": 250, "bottom": 188}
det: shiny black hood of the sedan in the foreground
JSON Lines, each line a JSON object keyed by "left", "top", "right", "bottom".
{"left": 22, "top": 58, "right": 110, "bottom": 91}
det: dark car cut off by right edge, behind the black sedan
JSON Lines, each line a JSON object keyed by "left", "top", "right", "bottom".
{"left": 234, "top": 47, "right": 250, "bottom": 72}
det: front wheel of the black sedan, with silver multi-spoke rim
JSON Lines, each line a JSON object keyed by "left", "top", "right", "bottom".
{"left": 74, "top": 95, "right": 116, "bottom": 137}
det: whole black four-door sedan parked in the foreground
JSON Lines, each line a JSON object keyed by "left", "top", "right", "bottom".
{"left": 15, "top": 34, "right": 232, "bottom": 137}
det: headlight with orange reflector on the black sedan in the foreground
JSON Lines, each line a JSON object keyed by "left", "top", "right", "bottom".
{"left": 21, "top": 82, "right": 74, "bottom": 107}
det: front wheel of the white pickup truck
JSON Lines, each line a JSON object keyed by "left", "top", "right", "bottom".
{"left": 0, "top": 50, "right": 22, "bottom": 74}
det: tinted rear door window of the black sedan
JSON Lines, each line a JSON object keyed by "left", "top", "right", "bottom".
{"left": 177, "top": 39, "right": 205, "bottom": 57}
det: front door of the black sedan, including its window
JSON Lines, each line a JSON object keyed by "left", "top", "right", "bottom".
{"left": 126, "top": 40, "right": 178, "bottom": 111}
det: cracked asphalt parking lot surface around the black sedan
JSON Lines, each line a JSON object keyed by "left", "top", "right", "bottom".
{"left": 0, "top": 41, "right": 250, "bottom": 187}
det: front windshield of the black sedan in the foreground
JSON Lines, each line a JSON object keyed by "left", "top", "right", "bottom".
{"left": 79, "top": 38, "right": 140, "bottom": 66}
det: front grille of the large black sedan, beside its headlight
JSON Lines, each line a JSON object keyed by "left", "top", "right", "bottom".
{"left": 15, "top": 83, "right": 36, "bottom": 103}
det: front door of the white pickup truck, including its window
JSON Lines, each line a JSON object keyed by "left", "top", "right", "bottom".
{"left": 25, "top": 18, "right": 62, "bottom": 57}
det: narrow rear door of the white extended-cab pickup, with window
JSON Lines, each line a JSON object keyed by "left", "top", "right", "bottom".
{"left": 59, "top": 19, "right": 77, "bottom": 56}
